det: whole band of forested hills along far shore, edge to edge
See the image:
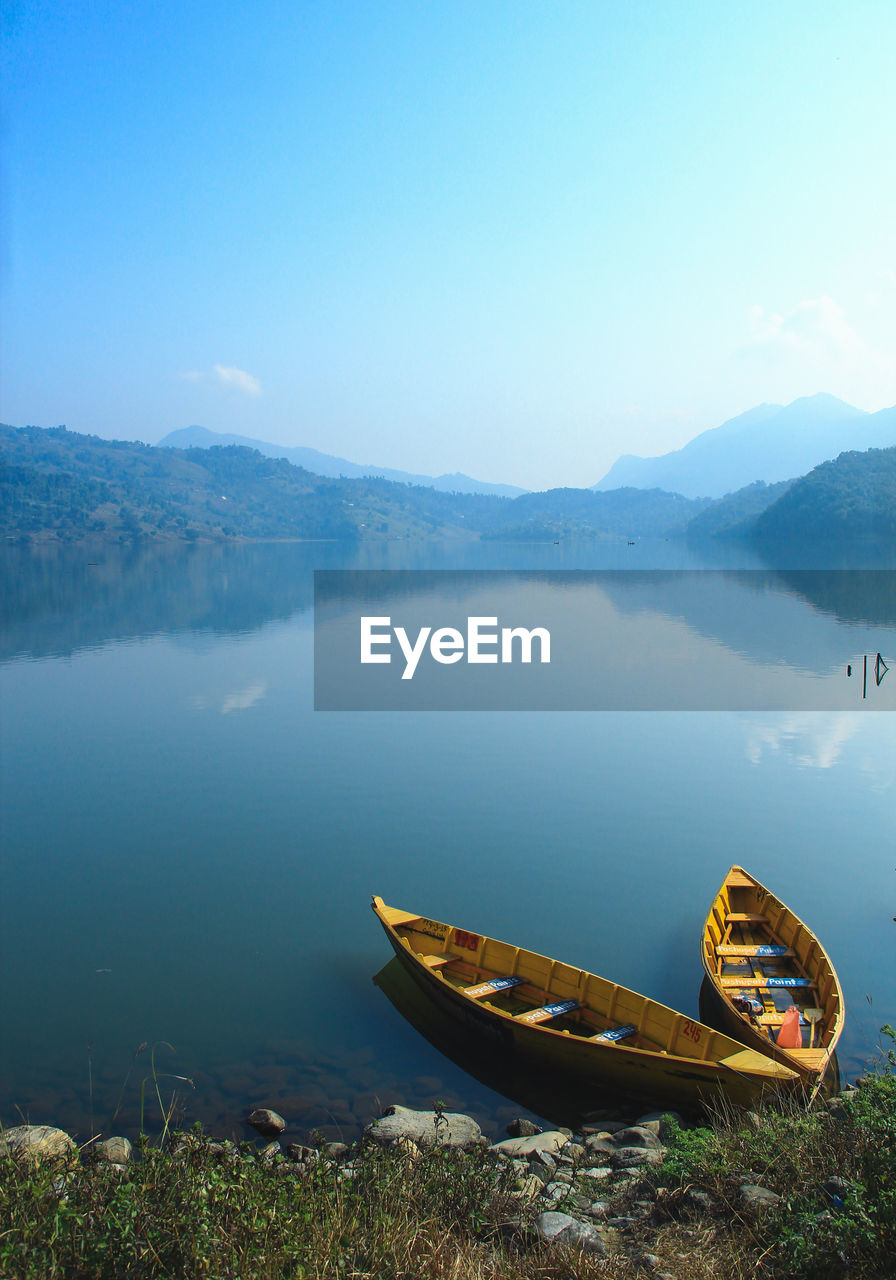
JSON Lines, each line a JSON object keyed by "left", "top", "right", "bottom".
{"left": 0, "top": 426, "right": 896, "bottom": 543}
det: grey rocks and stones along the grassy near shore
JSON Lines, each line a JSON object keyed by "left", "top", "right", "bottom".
{"left": 0, "top": 1091, "right": 855, "bottom": 1280}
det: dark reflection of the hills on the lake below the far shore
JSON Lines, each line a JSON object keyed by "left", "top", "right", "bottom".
{"left": 7, "top": 543, "right": 896, "bottom": 664}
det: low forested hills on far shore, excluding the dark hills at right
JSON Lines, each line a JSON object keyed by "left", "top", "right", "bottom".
{"left": 0, "top": 426, "right": 705, "bottom": 541}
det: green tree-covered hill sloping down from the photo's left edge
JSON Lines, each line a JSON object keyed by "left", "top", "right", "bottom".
{"left": 0, "top": 426, "right": 508, "bottom": 541}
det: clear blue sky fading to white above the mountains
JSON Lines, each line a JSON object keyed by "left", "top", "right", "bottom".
{"left": 0, "top": 0, "right": 896, "bottom": 488}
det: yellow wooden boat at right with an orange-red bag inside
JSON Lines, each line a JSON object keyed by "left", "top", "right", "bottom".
{"left": 701, "top": 867, "right": 846, "bottom": 1085}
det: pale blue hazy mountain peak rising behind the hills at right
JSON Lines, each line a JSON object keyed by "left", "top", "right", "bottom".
{"left": 593, "top": 394, "right": 896, "bottom": 498}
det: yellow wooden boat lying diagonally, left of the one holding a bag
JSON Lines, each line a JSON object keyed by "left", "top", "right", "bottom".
{"left": 372, "top": 897, "right": 799, "bottom": 1105}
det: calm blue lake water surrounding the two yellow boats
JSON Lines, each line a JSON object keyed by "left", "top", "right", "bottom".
{"left": 0, "top": 543, "right": 896, "bottom": 1139}
